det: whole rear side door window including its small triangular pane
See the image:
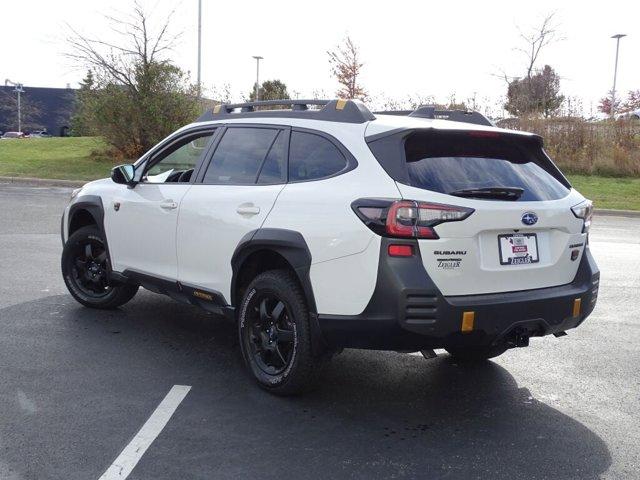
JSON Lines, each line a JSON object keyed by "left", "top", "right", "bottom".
{"left": 204, "top": 127, "right": 286, "bottom": 185}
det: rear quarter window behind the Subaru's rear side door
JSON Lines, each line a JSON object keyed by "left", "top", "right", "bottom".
{"left": 289, "top": 132, "right": 347, "bottom": 182}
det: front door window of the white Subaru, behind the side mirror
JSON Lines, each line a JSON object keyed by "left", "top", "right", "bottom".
{"left": 142, "top": 130, "right": 214, "bottom": 183}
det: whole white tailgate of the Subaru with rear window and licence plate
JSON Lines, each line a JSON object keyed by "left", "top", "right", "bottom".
{"left": 378, "top": 130, "right": 586, "bottom": 295}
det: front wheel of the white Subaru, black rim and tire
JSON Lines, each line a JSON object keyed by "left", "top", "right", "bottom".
{"left": 61, "top": 226, "right": 138, "bottom": 309}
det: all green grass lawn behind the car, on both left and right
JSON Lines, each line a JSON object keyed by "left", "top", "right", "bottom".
{"left": 0, "top": 137, "right": 640, "bottom": 210}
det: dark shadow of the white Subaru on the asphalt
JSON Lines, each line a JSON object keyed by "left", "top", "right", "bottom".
{"left": 0, "top": 292, "right": 611, "bottom": 479}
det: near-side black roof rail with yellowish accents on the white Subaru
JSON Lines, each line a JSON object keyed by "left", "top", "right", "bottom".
{"left": 197, "top": 99, "right": 376, "bottom": 123}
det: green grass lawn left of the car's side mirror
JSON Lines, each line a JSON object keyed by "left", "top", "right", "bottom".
{"left": 0, "top": 137, "right": 117, "bottom": 180}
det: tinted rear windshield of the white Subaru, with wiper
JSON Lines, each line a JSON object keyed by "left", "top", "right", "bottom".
{"left": 372, "top": 130, "right": 569, "bottom": 201}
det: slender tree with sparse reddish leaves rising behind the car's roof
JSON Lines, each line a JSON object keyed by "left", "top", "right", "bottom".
{"left": 327, "top": 36, "right": 367, "bottom": 100}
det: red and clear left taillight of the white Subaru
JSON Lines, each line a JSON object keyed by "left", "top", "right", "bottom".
{"left": 352, "top": 198, "right": 474, "bottom": 239}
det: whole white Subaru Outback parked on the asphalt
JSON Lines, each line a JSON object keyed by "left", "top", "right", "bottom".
{"left": 62, "top": 100, "right": 599, "bottom": 394}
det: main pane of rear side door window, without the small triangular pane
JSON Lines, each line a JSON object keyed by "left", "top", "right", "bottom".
{"left": 204, "top": 127, "right": 279, "bottom": 185}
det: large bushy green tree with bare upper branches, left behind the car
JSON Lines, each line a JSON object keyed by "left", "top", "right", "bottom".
{"left": 68, "top": 4, "right": 201, "bottom": 158}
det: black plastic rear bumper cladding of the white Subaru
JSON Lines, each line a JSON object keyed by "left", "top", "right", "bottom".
{"left": 318, "top": 238, "right": 600, "bottom": 350}
